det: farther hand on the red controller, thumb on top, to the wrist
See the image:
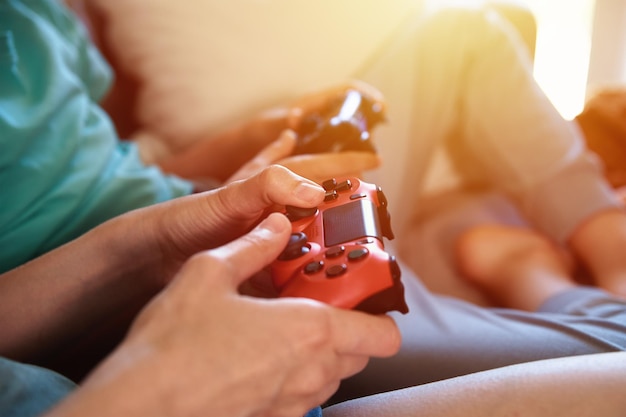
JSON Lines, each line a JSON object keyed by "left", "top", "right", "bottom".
{"left": 105, "top": 166, "right": 324, "bottom": 287}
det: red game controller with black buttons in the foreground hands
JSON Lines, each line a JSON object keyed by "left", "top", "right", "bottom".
{"left": 270, "top": 177, "right": 408, "bottom": 314}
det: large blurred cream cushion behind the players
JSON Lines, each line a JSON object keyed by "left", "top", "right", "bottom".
{"left": 91, "top": 0, "right": 419, "bottom": 146}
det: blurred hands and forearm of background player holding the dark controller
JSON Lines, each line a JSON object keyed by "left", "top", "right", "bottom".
{"left": 155, "top": 80, "right": 384, "bottom": 181}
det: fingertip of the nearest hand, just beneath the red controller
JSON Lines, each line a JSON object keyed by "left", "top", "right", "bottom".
{"left": 333, "top": 309, "right": 402, "bottom": 357}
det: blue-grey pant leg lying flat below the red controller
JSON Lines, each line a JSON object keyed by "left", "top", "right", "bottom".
{"left": 334, "top": 268, "right": 626, "bottom": 400}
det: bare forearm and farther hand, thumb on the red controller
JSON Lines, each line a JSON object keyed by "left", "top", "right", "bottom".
{"left": 0, "top": 167, "right": 323, "bottom": 360}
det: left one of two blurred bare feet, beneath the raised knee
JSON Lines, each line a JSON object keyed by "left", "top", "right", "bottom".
{"left": 457, "top": 225, "right": 577, "bottom": 311}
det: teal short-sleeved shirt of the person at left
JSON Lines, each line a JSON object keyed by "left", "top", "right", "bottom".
{"left": 0, "top": 0, "right": 192, "bottom": 272}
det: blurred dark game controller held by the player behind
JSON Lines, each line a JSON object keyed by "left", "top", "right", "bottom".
{"left": 294, "top": 89, "right": 386, "bottom": 154}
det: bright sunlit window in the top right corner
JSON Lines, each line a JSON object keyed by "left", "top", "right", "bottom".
{"left": 523, "top": 0, "right": 626, "bottom": 119}
